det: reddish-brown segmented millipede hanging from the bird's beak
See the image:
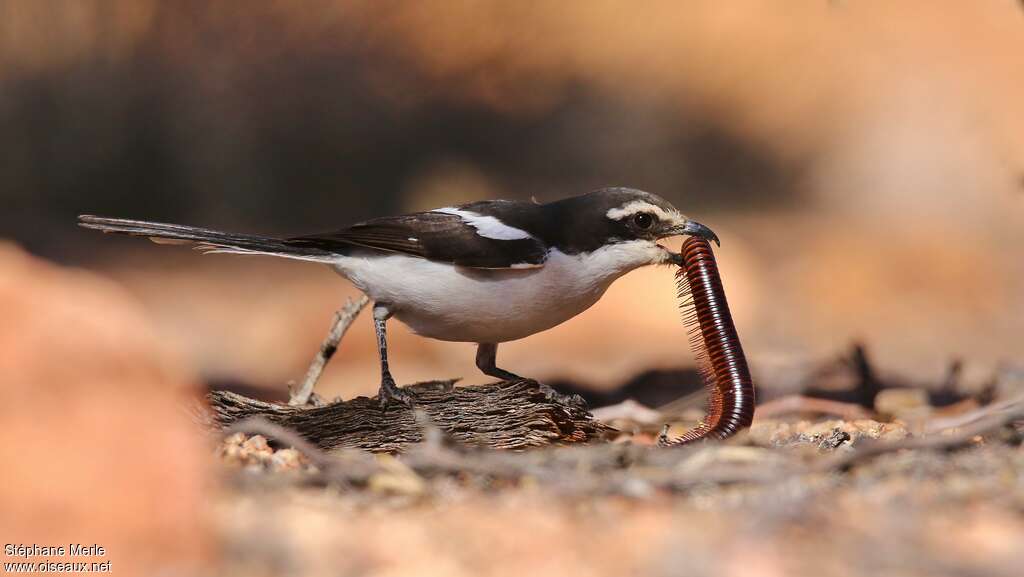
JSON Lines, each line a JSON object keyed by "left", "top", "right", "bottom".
{"left": 659, "top": 237, "right": 754, "bottom": 446}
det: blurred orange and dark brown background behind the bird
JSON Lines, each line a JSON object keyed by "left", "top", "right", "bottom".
{"left": 0, "top": 0, "right": 1024, "bottom": 396}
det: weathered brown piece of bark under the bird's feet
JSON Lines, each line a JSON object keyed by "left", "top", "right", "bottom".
{"left": 203, "top": 379, "right": 613, "bottom": 451}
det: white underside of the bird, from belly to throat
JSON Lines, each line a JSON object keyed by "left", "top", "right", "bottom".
{"left": 334, "top": 243, "right": 664, "bottom": 343}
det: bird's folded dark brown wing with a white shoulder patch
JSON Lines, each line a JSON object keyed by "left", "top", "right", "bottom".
{"left": 285, "top": 208, "right": 548, "bottom": 269}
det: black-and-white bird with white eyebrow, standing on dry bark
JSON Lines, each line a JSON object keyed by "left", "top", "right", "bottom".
{"left": 78, "top": 188, "right": 720, "bottom": 408}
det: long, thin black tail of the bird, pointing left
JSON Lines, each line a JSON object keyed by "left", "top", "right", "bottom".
{"left": 78, "top": 214, "right": 337, "bottom": 262}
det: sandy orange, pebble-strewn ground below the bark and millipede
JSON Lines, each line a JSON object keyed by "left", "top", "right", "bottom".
{"left": 209, "top": 421, "right": 1024, "bottom": 577}
